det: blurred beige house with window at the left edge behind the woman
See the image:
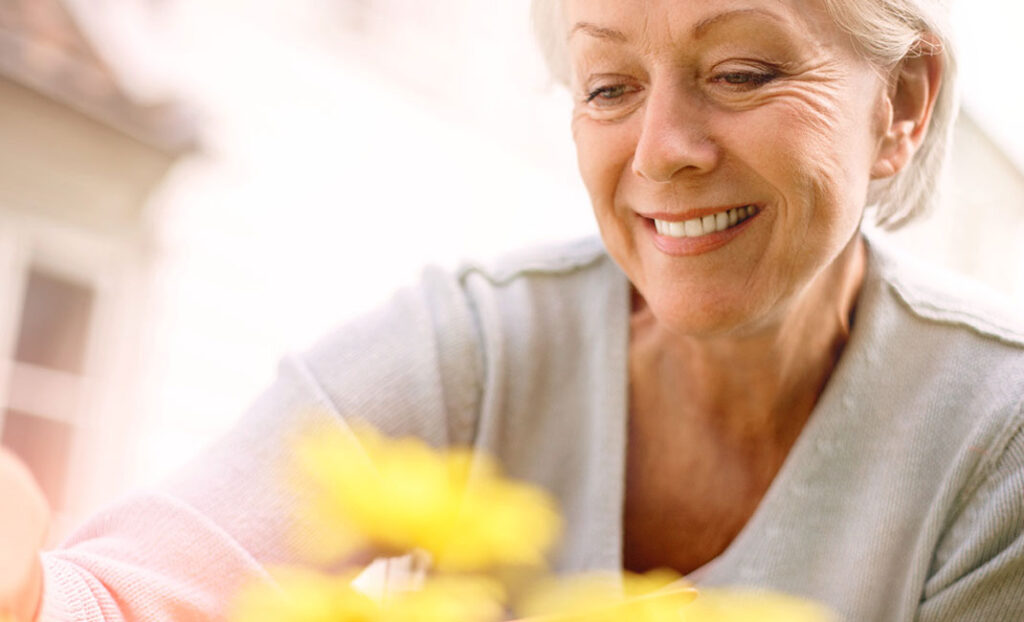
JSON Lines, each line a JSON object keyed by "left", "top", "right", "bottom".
{"left": 0, "top": 0, "right": 195, "bottom": 533}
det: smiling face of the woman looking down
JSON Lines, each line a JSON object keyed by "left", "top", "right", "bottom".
{"left": 564, "top": 0, "right": 889, "bottom": 335}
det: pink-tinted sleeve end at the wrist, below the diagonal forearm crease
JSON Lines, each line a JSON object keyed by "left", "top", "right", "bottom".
{"left": 39, "top": 493, "right": 266, "bottom": 622}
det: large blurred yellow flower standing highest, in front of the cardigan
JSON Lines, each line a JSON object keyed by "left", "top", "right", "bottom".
{"left": 297, "top": 426, "right": 560, "bottom": 571}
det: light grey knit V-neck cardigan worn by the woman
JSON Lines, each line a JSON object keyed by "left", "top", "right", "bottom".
{"left": 43, "top": 234, "right": 1024, "bottom": 622}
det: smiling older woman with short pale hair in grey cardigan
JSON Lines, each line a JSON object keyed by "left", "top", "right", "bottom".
{"left": 7, "top": 0, "right": 1024, "bottom": 622}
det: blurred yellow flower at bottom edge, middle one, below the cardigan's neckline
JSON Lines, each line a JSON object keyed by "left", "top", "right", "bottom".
{"left": 520, "top": 570, "right": 697, "bottom": 622}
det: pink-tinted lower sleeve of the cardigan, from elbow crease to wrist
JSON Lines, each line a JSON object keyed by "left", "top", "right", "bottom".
{"left": 39, "top": 358, "right": 344, "bottom": 622}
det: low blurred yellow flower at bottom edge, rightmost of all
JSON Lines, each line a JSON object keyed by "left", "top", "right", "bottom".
{"left": 679, "top": 589, "right": 835, "bottom": 622}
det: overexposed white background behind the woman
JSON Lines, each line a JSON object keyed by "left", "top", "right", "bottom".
{"left": 0, "top": 0, "right": 1024, "bottom": 541}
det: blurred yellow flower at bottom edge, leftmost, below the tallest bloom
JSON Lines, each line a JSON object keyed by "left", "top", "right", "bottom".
{"left": 229, "top": 569, "right": 504, "bottom": 622}
